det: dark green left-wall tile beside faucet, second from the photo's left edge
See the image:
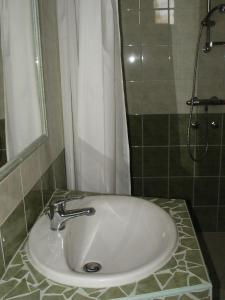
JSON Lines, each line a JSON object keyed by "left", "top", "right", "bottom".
{"left": 24, "top": 181, "right": 43, "bottom": 231}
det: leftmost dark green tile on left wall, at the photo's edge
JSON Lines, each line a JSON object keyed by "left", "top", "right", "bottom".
{"left": 1, "top": 201, "right": 27, "bottom": 265}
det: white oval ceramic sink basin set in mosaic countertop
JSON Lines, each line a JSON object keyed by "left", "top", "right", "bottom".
{"left": 27, "top": 196, "right": 177, "bottom": 288}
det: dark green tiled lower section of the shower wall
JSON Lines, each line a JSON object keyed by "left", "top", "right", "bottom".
{"left": 128, "top": 114, "right": 225, "bottom": 231}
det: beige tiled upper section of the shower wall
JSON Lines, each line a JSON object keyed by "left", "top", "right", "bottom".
{"left": 120, "top": 0, "right": 225, "bottom": 114}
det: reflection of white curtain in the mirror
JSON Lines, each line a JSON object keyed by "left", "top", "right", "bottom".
{"left": 0, "top": 0, "right": 42, "bottom": 160}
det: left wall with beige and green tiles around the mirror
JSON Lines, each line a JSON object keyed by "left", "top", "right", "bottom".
{"left": 0, "top": 0, "right": 66, "bottom": 275}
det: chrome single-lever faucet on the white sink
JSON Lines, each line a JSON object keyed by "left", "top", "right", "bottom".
{"left": 46, "top": 195, "right": 95, "bottom": 230}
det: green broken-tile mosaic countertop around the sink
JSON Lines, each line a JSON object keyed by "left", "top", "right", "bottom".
{"left": 0, "top": 192, "right": 212, "bottom": 300}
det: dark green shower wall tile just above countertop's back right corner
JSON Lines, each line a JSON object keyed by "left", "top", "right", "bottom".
{"left": 169, "top": 177, "right": 193, "bottom": 204}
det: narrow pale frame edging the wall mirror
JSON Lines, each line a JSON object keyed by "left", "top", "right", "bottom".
{"left": 0, "top": 0, "right": 48, "bottom": 181}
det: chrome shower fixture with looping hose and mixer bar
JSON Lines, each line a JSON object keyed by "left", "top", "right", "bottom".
{"left": 186, "top": 0, "right": 225, "bottom": 162}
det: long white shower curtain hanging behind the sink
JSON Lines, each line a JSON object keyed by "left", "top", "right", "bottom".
{"left": 57, "top": 0, "right": 130, "bottom": 194}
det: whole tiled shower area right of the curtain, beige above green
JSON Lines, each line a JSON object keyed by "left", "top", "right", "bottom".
{"left": 120, "top": 0, "right": 225, "bottom": 299}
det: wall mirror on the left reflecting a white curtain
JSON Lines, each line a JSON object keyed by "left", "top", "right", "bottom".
{"left": 0, "top": 0, "right": 47, "bottom": 173}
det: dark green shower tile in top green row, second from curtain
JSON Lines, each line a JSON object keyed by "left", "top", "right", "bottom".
{"left": 143, "top": 115, "right": 169, "bottom": 146}
